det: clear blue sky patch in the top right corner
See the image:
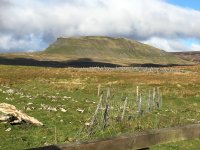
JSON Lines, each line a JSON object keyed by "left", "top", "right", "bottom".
{"left": 167, "top": 0, "right": 200, "bottom": 10}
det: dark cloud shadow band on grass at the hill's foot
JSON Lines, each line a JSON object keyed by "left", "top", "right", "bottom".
{"left": 0, "top": 57, "right": 191, "bottom": 68}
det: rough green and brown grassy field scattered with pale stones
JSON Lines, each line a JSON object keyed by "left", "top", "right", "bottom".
{"left": 0, "top": 65, "right": 200, "bottom": 150}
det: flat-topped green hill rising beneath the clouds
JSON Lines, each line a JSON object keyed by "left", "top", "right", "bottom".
{"left": 44, "top": 36, "right": 188, "bottom": 65}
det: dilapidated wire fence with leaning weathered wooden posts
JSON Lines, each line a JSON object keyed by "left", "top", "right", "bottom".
{"left": 87, "top": 85, "right": 162, "bottom": 134}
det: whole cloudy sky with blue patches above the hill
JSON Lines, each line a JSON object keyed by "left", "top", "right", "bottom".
{"left": 0, "top": 0, "right": 200, "bottom": 53}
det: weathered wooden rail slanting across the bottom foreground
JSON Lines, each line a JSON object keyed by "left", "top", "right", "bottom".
{"left": 30, "top": 124, "right": 200, "bottom": 150}
